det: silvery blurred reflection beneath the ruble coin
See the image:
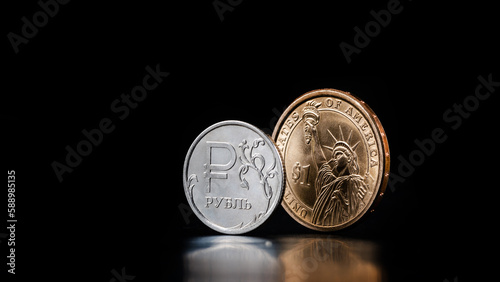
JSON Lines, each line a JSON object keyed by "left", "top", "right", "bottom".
{"left": 183, "top": 236, "right": 281, "bottom": 281}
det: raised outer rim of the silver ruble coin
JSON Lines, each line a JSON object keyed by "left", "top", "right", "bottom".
{"left": 182, "top": 120, "right": 285, "bottom": 234}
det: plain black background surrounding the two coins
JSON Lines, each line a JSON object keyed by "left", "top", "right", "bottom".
{"left": 1, "top": 1, "right": 500, "bottom": 281}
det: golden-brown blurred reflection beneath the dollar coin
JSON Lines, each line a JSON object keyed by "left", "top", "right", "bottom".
{"left": 279, "top": 237, "right": 382, "bottom": 281}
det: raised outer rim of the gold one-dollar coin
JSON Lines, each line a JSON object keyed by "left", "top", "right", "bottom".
{"left": 272, "top": 88, "right": 390, "bottom": 231}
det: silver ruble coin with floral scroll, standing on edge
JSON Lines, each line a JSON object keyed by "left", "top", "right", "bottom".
{"left": 183, "top": 120, "right": 284, "bottom": 234}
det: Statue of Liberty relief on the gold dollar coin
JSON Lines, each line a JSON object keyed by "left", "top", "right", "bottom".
{"left": 302, "top": 100, "right": 368, "bottom": 226}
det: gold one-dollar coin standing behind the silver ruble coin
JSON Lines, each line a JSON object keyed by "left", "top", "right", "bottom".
{"left": 273, "top": 89, "right": 390, "bottom": 231}
